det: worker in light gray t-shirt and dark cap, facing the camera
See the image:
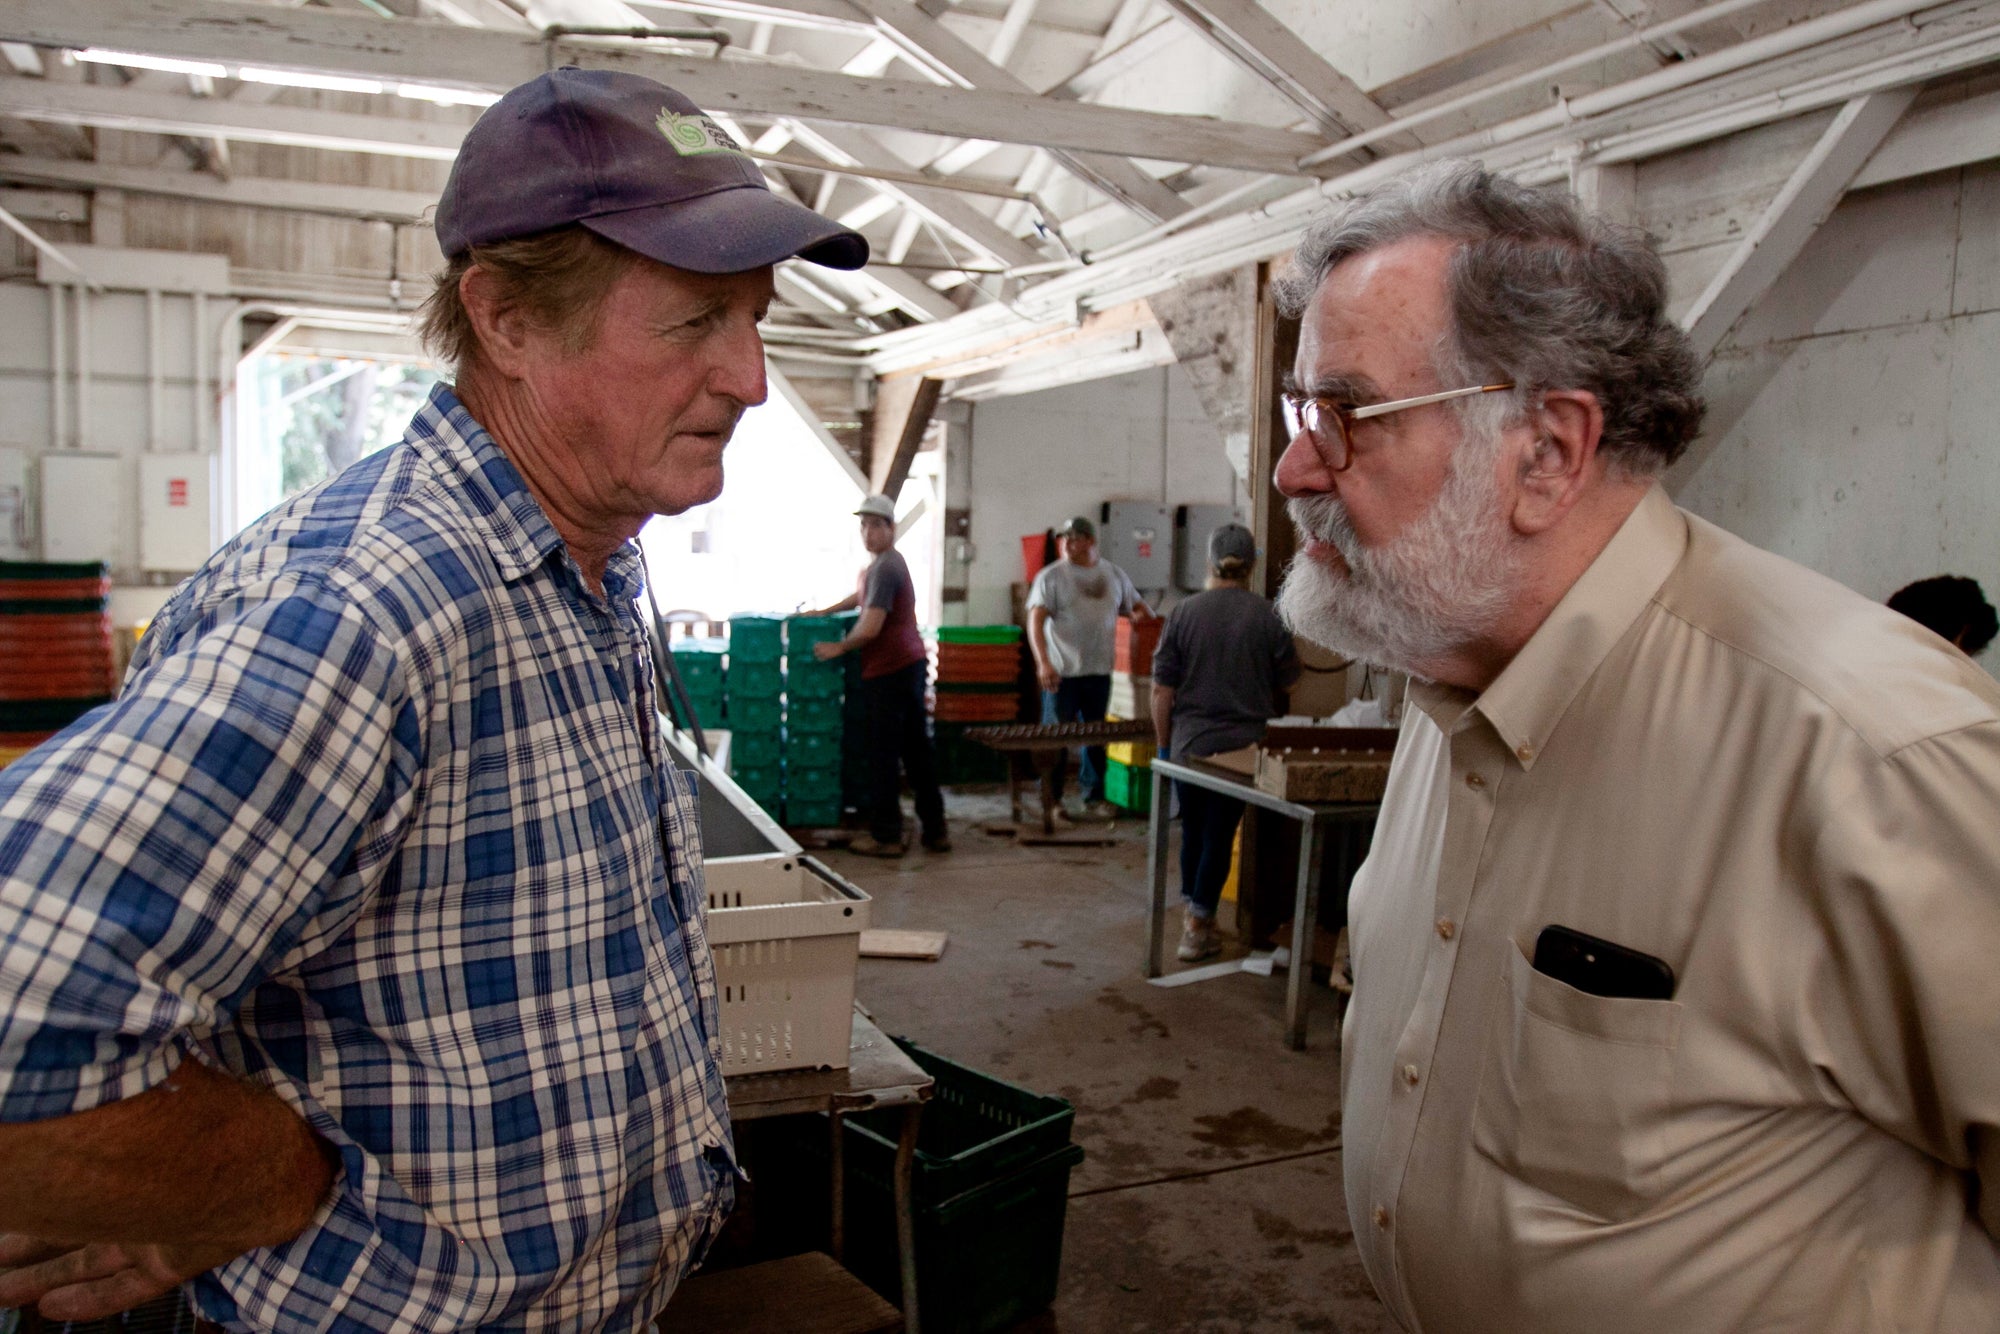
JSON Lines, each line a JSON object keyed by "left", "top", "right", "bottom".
{"left": 1028, "top": 516, "right": 1152, "bottom": 818}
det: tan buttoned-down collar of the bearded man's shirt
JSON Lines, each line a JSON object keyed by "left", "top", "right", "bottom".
{"left": 1410, "top": 484, "right": 1688, "bottom": 768}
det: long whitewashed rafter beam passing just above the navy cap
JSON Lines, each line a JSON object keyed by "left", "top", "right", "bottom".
{"left": 0, "top": 0, "right": 1318, "bottom": 174}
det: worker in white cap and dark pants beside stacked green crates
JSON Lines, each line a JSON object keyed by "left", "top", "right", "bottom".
{"left": 812, "top": 496, "right": 952, "bottom": 856}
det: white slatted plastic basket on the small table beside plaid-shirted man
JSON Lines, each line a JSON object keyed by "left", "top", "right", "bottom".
{"left": 704, "top": 854, "right": 868, "bottom": 1074}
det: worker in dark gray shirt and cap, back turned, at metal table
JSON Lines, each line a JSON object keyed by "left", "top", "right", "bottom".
{"left": 1152, "top": 524, "right": 1298, "bottom": 962}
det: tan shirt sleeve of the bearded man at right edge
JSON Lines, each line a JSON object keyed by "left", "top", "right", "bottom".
{"left": 1798, "top": 724, "right": 2000, "bottom": 1238}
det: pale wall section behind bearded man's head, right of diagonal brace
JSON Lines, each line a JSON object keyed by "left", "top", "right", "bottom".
{"left": 1672, "top": 164, "right": 2000, "bottom": 636}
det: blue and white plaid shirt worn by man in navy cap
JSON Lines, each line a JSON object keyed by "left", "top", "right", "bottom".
{"left": 0, "top": 386, "right": 734, "bottom": 1332}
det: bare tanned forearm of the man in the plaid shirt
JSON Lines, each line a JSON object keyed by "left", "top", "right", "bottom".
{"left": 0, "top": 1060, "right": 336, "bottom": 1250}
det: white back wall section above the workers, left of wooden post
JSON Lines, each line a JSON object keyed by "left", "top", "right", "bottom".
{"left": 946, "top": 366, "right": 1244, "bottom": 624}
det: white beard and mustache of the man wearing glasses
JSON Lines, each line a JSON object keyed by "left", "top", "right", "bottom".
{"left": 1278, "top": 428, "right": 1520, "bottom": 678}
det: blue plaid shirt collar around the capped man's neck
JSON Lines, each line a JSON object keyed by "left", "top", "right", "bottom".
{"left": 410, "top": 382, "right": 640, "bottom": 604}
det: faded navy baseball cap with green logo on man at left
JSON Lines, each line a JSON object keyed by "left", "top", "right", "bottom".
{"left": 436, "top": 68, "right": 868, "bottom": 274}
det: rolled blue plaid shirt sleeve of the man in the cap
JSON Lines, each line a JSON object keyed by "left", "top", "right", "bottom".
{"left": 0, "top": 586, "right": 420, "bottom": 1120}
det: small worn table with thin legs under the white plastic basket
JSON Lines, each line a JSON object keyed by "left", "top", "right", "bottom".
{"left": 726, "top": 1004, "right": 936, "bottom": 1334}
